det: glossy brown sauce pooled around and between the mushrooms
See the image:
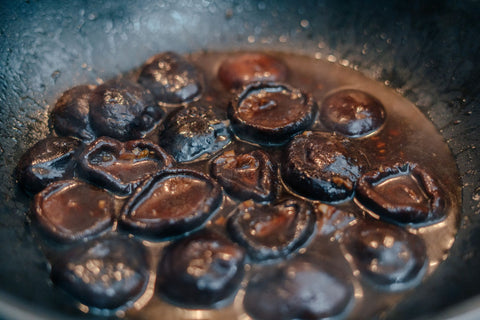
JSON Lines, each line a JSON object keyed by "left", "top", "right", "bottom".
{"left": 29, "top": 52, "right": 461, "bottom": 320}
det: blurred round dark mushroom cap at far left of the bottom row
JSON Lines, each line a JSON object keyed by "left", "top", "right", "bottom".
{"left": 51, "top": 237, "right": 149, "bottom": 309}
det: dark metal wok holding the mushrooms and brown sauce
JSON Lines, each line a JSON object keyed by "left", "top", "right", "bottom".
{"left": 0, "top": 0, "right": 480, "bottom": 319}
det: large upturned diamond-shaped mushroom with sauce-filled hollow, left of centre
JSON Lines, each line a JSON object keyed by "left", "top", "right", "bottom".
{"left": 120, "top": 169, "right": 222, "bottom": 238}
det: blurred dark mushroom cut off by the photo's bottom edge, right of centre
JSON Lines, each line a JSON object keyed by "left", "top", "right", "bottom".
{"left": 243, "top": 259, "right": 354, "bottom": 320}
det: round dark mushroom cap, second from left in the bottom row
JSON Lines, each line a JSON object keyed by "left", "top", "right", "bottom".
{"left": 157, "top": 230, "right": 245, "bottom": 308}
